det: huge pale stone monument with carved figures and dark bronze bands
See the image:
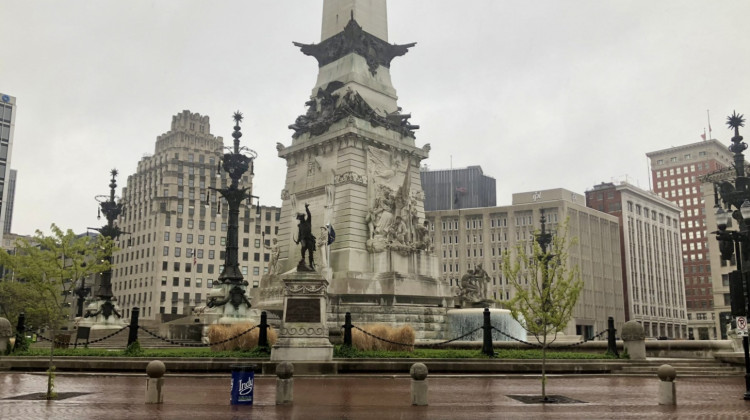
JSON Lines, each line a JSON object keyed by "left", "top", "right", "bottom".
{"left": 259, "top": 0, "right": 451, "bottom": 334}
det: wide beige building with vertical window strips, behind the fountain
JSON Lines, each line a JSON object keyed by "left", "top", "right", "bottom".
{"left": 427, "top": 188, "right": 625, "bottom": 336}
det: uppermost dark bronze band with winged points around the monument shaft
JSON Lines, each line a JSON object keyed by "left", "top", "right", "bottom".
{"left": 294, "top": 18, "right": 417, "bottom": 76}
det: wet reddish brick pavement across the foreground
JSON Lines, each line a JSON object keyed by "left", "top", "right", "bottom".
{"left": 0, "top": 372, "right": 750, "bottom": 420}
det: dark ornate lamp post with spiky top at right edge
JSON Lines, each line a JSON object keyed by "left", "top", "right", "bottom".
{"left": 714, "top": 112, "right": 750, "bottom": 400}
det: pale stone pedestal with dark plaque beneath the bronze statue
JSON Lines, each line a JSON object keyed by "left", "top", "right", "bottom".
{"left": 271, "top": 271, "right": 333, "bottom": 361}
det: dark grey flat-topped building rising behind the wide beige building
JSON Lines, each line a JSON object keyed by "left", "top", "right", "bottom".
{"left": 419, "top": 166, "right": 497, "bottom": 211}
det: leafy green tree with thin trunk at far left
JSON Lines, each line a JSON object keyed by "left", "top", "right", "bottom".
{"left": 0, "top": 224, "right": 113, "bottom": 398}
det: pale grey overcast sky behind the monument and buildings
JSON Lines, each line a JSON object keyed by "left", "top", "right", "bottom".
{"left": 0, "top": 0, "right": 750, "bottom": 234}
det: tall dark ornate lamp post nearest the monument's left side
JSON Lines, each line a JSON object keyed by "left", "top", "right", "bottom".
{"left": 207, "top": 111, "right": 257, "bottom": 317}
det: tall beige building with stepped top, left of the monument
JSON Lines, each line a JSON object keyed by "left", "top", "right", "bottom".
{"left": 112, "top": 111, "right": 280, "bottom": 320}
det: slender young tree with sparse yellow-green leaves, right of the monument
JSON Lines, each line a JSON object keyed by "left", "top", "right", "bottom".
{"left": 503, "top": 215, "right": 583, "bottom": 401}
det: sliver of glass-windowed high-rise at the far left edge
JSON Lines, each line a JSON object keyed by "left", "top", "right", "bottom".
{"left": 0, "top": 93, "right": 16, "bottom": 242}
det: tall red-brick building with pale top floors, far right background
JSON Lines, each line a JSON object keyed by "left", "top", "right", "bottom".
{"left": 646, "top": 139, "right": 733, "bottom": 339}
